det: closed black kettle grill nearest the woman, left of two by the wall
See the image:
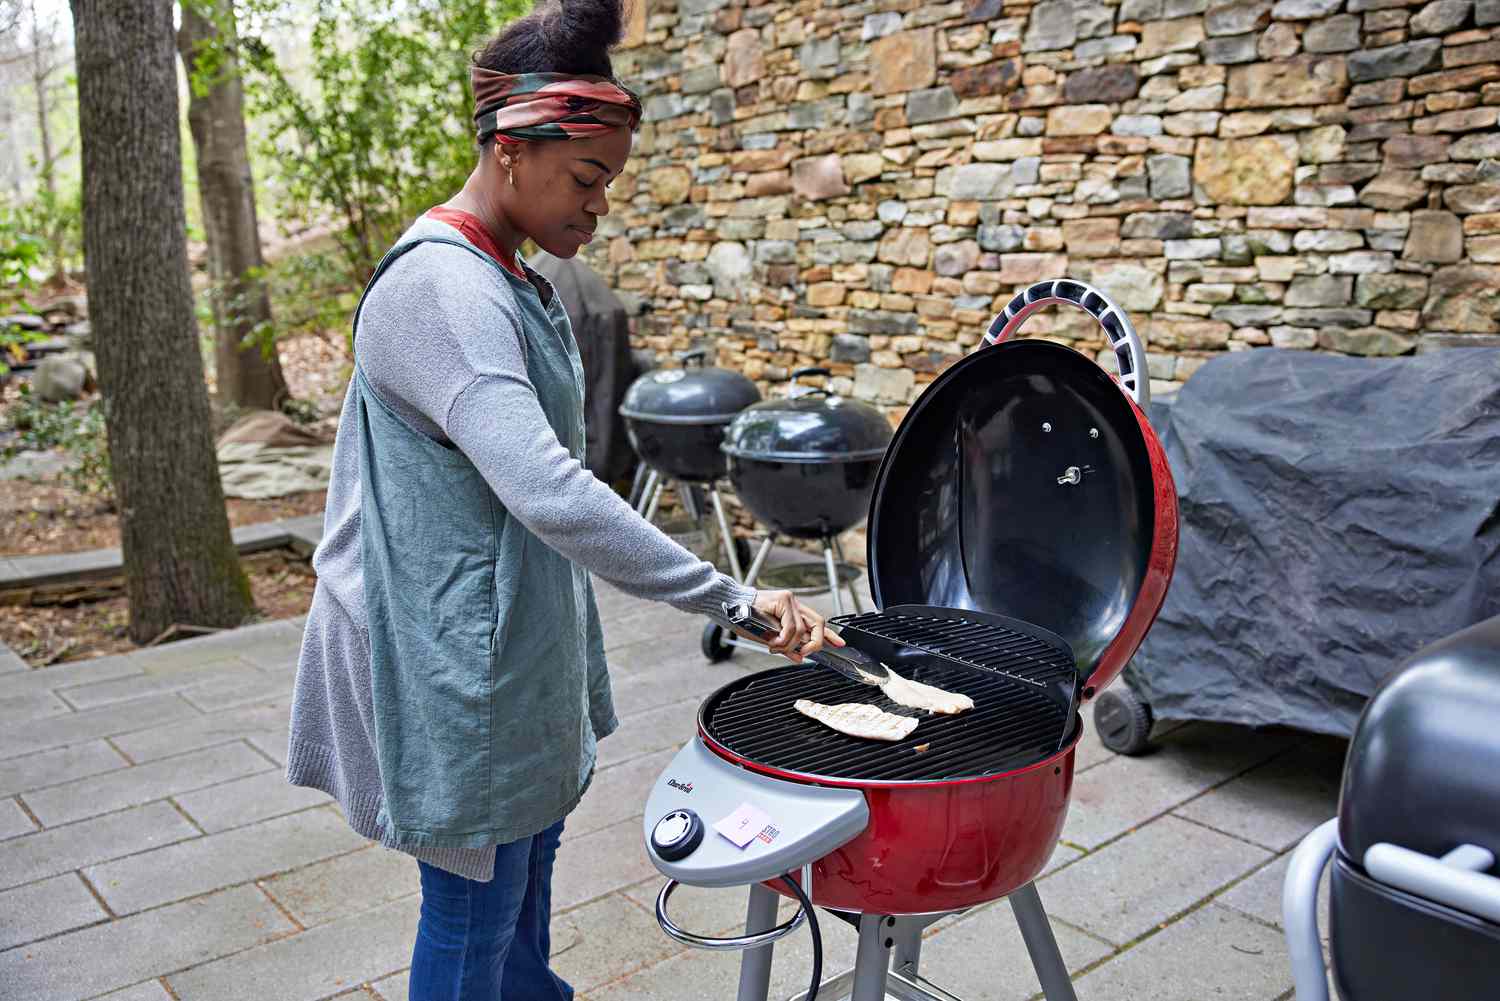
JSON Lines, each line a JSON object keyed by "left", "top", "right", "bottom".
{"left": 620, "top": 348, "right": 761, "bottom": 579}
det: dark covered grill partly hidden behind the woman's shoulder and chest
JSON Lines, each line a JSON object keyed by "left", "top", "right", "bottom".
{"left": 527, "top": 251, "right": 636, "bottom": 483}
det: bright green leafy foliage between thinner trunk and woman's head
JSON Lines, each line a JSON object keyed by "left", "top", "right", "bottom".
{"left": 240, "top": 0, "right": 528, "bottom": 285}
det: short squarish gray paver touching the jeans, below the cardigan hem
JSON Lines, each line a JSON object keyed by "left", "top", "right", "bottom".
{"left": 261, "top": 845, "right": 422, "bottom": 927}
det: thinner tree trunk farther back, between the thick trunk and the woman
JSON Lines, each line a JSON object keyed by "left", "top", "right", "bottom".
{"left": 177, "top": 0, "right": 287, "bottom": 410}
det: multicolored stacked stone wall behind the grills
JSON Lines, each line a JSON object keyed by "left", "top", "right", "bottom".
{"left": 590, "top": 0, "right": 1500, "bottom": 417}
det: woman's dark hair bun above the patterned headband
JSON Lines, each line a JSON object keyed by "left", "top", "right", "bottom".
{"left": 474, "top": 0, "right": 627, "bottom": 78}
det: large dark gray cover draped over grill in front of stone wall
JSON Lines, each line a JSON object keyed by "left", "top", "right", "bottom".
{"left": 1127, "top": 348, "right": 1500, "bottom": 735}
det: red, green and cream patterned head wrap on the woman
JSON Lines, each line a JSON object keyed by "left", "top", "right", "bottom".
{"left": 470, "top": 66, "right": 641, "bottom": 143}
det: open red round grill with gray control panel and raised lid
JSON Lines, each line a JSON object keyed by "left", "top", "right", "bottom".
{"left": 645, "top": 281, "right": 1176, "bottom": 1001}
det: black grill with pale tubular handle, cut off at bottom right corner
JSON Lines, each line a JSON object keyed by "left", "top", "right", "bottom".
{"left": 1283, "top": 617, "right": 1500, "bottom": 1001}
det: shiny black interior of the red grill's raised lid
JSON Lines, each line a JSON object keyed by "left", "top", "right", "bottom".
{"left": 869, "top": 341, "right": 1155, "bottom": 677}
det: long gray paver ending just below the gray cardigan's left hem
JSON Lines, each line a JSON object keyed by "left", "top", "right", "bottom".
{"left": 84, "top": 809, "right": 366, "bottom": 914}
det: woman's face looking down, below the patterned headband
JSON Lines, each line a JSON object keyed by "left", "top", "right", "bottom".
{"left": 495, "top": 128, "right": 635, "bottom": 258}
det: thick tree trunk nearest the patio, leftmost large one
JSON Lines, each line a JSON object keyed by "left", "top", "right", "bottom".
{"left": 72, "top": 0, "right": 254, "bottom": 642}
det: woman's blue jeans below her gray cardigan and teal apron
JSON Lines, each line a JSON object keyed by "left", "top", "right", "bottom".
{"left": 408, "top": 821, "right": 573, "bottom": 1001}
